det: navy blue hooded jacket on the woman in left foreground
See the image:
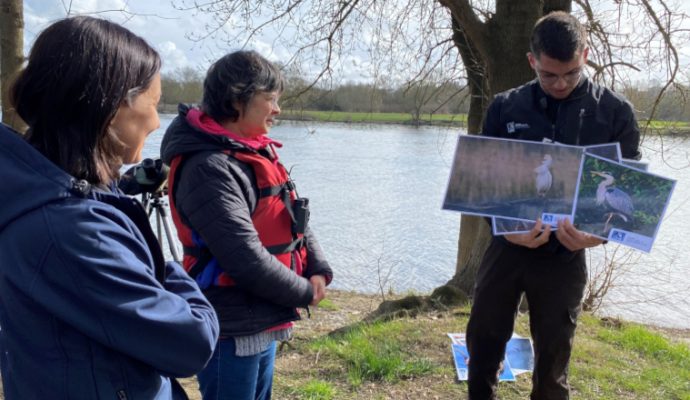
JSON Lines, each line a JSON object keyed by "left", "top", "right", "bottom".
{"left": 0, "top": 125, "right": 218, "bottom": 400}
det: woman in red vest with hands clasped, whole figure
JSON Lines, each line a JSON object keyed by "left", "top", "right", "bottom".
{"left": 161, "top": 51, "right": 333, "bottom": 400}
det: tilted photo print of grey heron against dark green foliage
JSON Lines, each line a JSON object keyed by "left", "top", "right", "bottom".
{"left": 573, "top": 155, "right": 676, "bottom": 252}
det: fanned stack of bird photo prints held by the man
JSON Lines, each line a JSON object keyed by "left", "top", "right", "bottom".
{"left": 443, "top": 135, "right": 676, "bottom": 252}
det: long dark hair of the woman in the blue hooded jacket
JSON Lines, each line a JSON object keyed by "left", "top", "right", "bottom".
{"left": 10, "top": 16, "right": 161, "bottom": 184}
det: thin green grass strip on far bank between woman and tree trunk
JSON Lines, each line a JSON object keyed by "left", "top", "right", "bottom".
{"left": 281, "top": 110, "right": 467, "bottom": 126}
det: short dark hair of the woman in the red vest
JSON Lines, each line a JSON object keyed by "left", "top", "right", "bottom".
{"left": 201, "top": 51, "right": 285, "bottom": 122}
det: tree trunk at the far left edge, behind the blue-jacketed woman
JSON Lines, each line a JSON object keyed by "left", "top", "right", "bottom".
{"left": 0, "top": 0, "right": 26, "bottom": 132}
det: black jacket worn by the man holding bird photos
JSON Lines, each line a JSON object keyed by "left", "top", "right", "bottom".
{"left": 482, "top": 78, "right": 640, "bottom": 253}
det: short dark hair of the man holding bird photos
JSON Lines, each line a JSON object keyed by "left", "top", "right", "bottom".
{"left": 530, "top": 11, "right": 587, "bottom": 62}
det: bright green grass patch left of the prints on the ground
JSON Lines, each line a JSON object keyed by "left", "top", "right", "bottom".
{"left": 309, "top": 321, "right": 432, "bottom": 387}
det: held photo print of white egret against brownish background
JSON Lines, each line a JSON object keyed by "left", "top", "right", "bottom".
{"left": 443, "top": 135, "right": 584, "bottom": 221}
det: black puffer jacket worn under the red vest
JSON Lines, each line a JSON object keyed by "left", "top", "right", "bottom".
{"left": 161, "top": 105, "right": 333, "bottom": 336}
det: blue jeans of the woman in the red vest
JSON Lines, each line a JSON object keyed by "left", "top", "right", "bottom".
{"left": 197, "top": 338, "right": 276, "bottom": 400}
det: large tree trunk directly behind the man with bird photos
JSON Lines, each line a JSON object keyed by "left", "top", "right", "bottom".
{"left": 439, "top": 0, "right": 572, "bottom": 296}
